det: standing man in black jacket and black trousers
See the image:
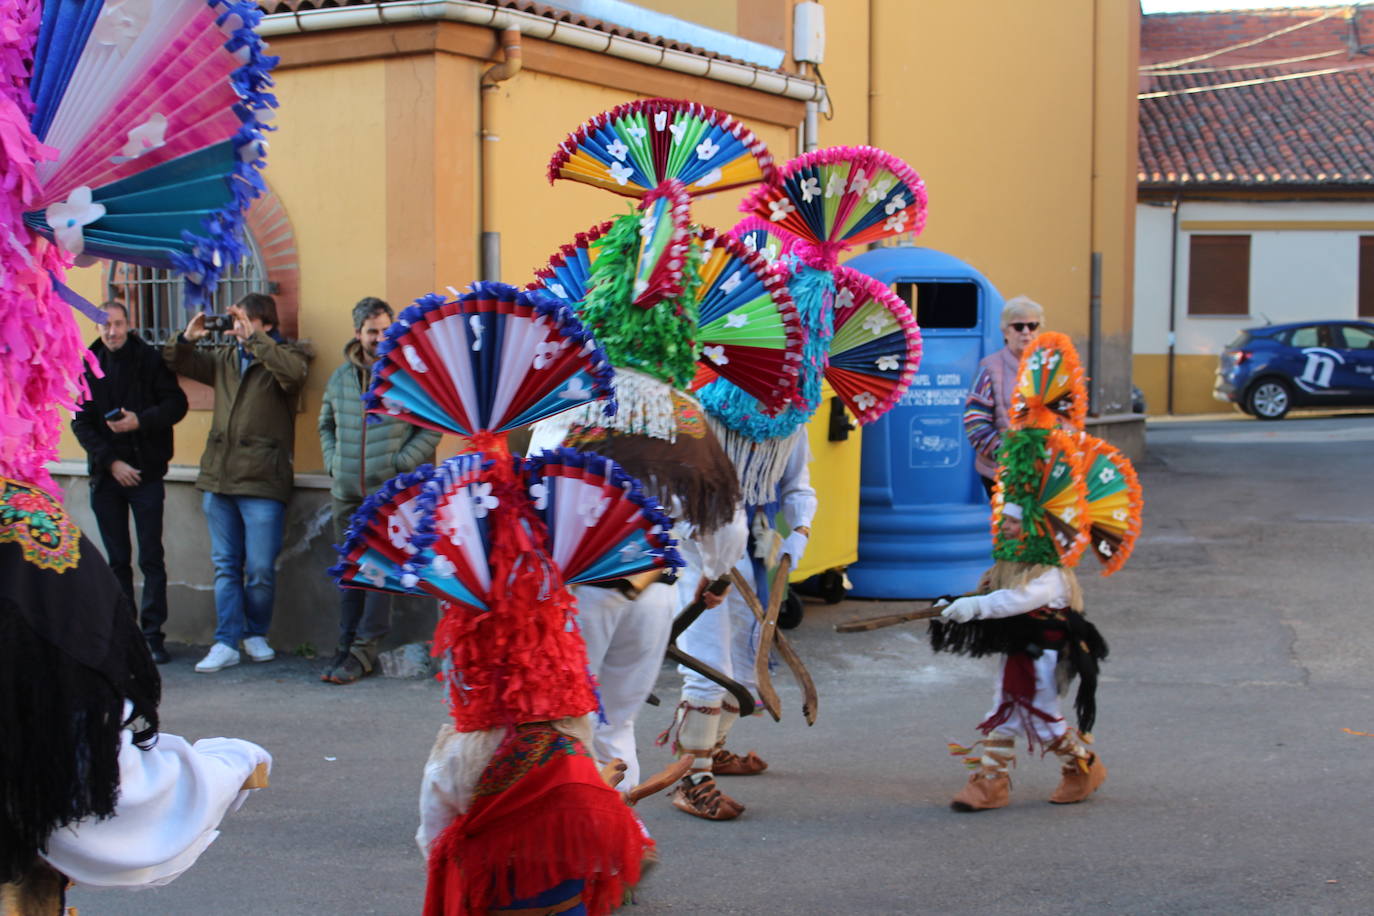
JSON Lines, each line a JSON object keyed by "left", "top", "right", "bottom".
{"left": 71, "top": 299, "right": 187, "bottom": 665}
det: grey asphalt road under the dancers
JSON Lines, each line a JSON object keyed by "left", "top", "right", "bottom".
{"left": 71, "top": 415, "right": 1374, "bottom": 916}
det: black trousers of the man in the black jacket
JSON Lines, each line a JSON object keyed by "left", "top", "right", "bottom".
{"left": 91, "top": 474, "right": 168, "bottom": 643}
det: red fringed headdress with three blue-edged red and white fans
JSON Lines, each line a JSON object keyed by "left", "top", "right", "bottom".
{"left": 334, "top": 283, "right": 680, "bottom": 731}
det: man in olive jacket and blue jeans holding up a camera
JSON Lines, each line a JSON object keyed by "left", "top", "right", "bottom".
{"left": 162, "top": 293, "right": 311, "bottom": 673}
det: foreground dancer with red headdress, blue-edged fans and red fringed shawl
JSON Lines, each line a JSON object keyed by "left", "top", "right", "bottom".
{"left": 334, "top": 283, "right": 680, "bottom": 916}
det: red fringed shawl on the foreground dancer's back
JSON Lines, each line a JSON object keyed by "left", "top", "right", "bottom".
{"left": 425, "top": 722, "right": 654, "bottom": 916}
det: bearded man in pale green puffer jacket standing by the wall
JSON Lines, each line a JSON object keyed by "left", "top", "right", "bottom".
{"left": 320, "top": 297, "right": 440, "bottom": 684}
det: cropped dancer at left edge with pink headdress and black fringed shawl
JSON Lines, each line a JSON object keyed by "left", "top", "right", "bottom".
{"left": 0, "top": 0, "right": 275, "bottom": 916}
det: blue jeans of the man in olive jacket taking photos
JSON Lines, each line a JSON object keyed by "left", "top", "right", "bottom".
{"left": 201, "top": 493, "right": 286, "bottom": 650}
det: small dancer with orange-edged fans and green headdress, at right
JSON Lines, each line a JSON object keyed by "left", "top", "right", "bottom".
{"left": 930, "top": 334, "right": 1142, "bottom": 812}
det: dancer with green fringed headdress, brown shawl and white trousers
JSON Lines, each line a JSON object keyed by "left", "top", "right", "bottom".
{"left": 532, "top": 99, "right": 801, "bottom": 810}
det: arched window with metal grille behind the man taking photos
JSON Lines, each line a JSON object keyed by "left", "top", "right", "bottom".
{"left": 106, "top": 238, "right": 267, "bottom": 345}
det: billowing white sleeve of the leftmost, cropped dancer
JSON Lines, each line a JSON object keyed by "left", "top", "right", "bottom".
{"left": 44, "top": 714, "right": 272, "bottom": 889}
